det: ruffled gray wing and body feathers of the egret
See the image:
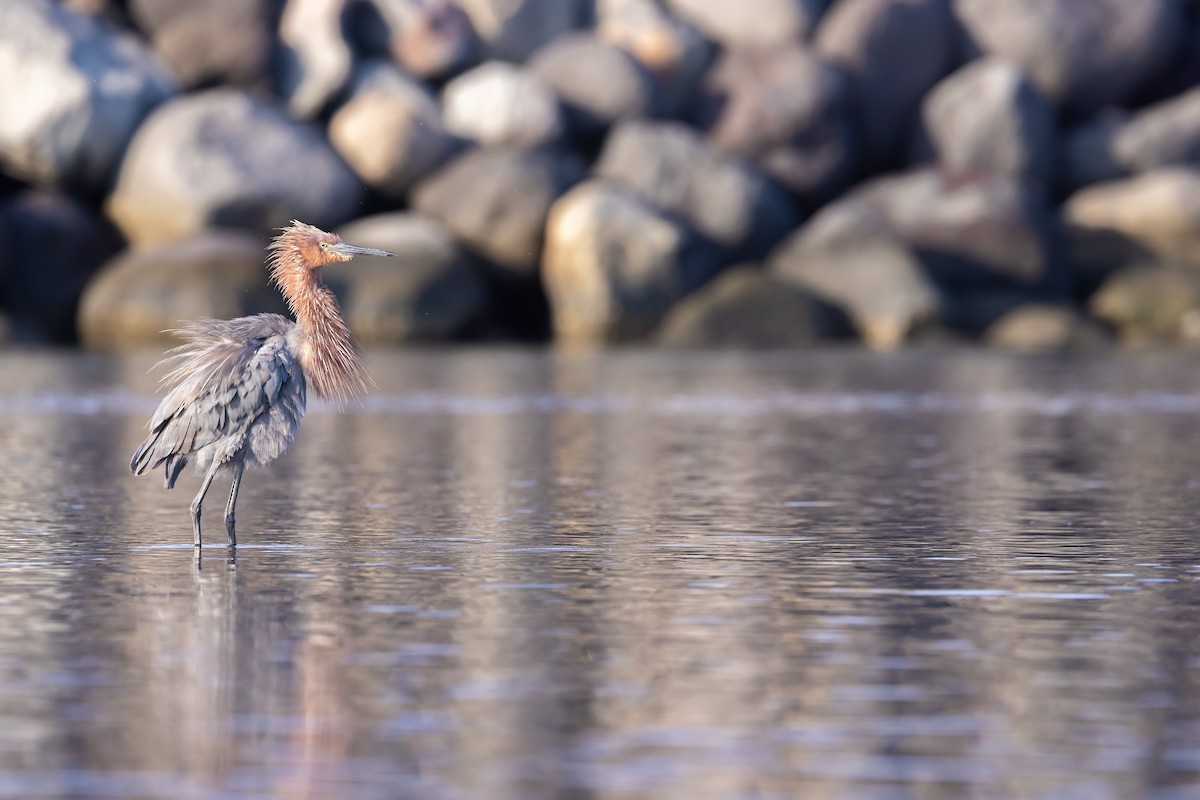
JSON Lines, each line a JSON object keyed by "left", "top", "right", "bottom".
{"left": 130, "top": 314, "right": 304, "bottom": 488}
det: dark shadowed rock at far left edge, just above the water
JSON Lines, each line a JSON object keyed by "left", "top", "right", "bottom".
{"left": 0, "top": 190, "right": 120, "bottom": 343}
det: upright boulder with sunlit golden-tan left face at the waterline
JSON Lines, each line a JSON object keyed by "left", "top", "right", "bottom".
{"left": 541, "top": 181, "right": 720, "bottom": 344}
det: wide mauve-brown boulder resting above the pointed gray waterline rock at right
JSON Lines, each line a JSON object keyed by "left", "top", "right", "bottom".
{"left": 799, "top": 168, "right": 1062, "bottom": 291}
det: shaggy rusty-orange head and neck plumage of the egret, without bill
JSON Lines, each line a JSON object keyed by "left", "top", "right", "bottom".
{"left": 268, "top": 223, "right": 368, "bottom": 405}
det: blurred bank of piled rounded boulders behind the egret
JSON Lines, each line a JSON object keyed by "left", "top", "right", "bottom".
{"left": 0, "top": 0, "right": 1200, "bottom": 350}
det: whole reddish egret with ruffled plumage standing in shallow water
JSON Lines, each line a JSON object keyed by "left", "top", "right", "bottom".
{"left": 130, "top": 219, "right": 395, "bottom": 547}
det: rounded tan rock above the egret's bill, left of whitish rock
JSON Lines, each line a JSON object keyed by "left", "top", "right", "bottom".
{"left": 329, "top": 61, "right": 458, "bottom": 197}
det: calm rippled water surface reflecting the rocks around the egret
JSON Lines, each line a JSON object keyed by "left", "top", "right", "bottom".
{"left": 0, "top": 351, "right": 1200, "bottom": 800}
